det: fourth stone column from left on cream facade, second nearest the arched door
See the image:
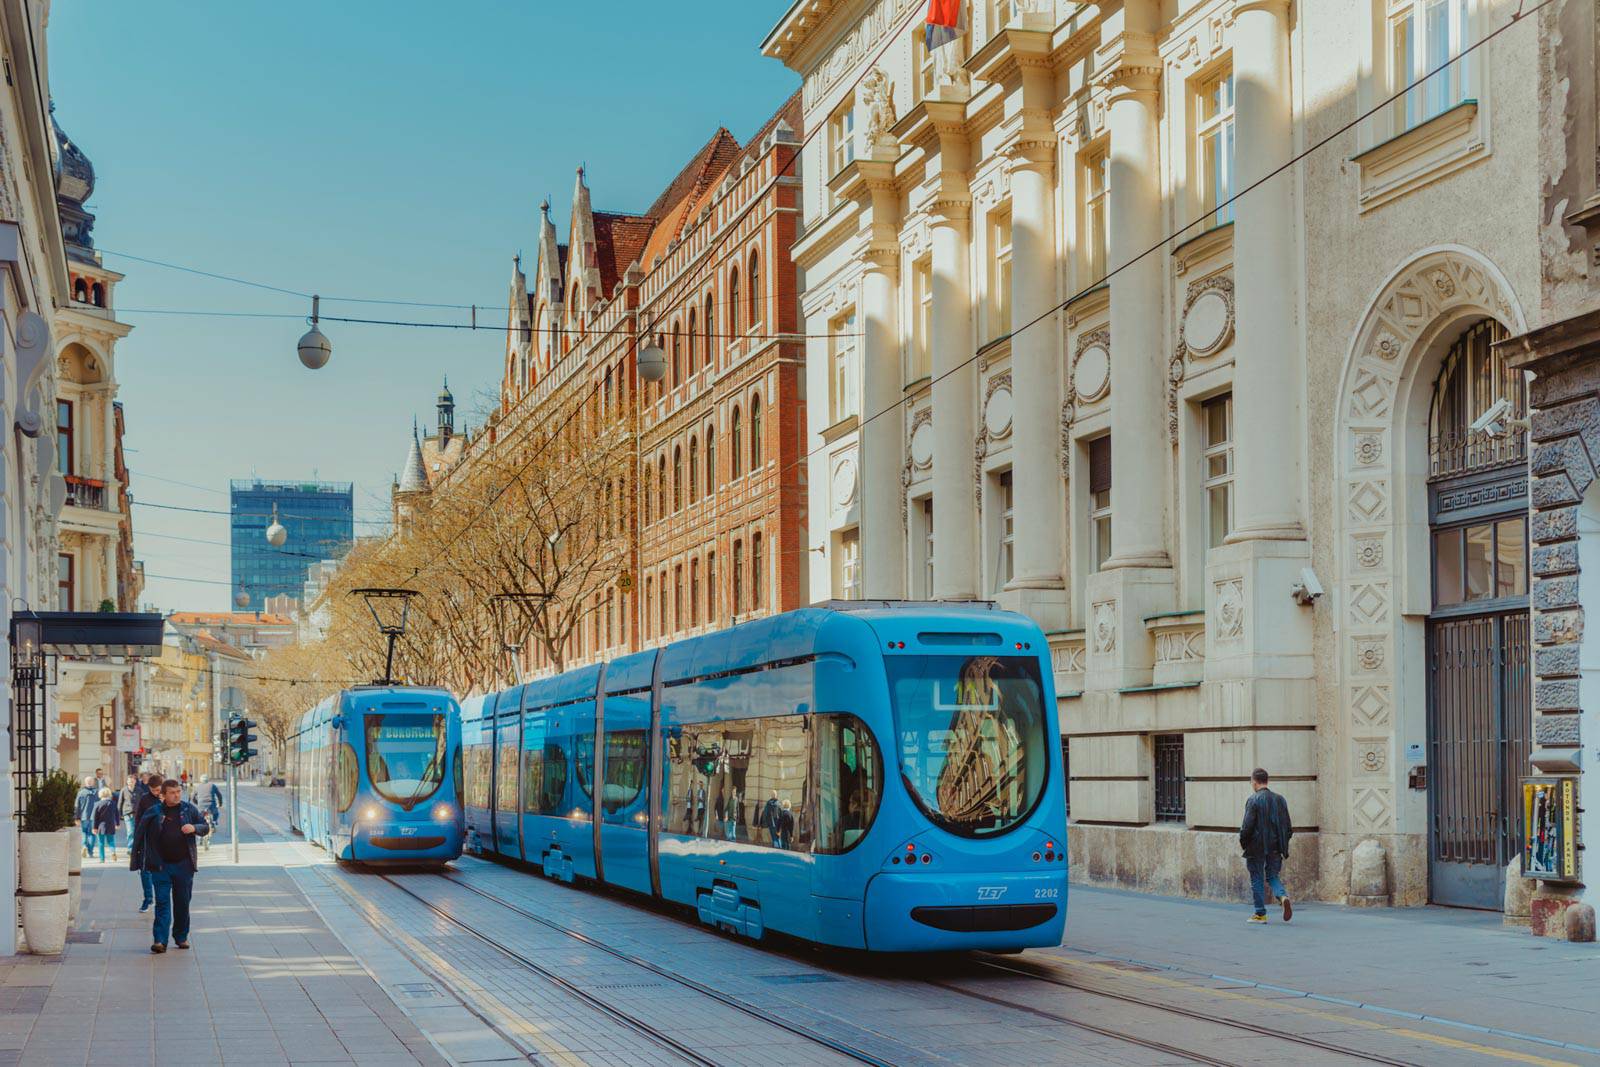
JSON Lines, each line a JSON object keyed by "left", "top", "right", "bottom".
{"left": 1106, "top": 45, "right": 1171, "bottom": 569}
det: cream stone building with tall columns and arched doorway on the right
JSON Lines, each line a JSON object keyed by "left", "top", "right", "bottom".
{"left": 763, "top": 0, "right": 1592, "bottom": 907}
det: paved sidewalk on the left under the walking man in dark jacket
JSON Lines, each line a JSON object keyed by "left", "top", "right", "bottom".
{"left": 0, "top": 833, "right": 446, "bottom": 1067}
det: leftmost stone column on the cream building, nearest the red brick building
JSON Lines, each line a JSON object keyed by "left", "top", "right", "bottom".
{"left": 858, "top": 246, "right": 906, "bottom": 600}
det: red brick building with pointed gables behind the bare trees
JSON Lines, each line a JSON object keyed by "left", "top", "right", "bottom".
{"left": 494, "top": 94, "right": 808, "bottom": 669}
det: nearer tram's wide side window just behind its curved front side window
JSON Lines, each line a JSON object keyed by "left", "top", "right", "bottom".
{"left": 666, "top": 715, "right": 813, "bottom": 853}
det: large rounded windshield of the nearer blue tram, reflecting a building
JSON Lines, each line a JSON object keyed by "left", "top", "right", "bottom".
{"left": 885, "top": 656, "right": 1050, "bottom": 837}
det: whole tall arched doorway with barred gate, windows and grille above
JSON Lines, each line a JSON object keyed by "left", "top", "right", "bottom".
{"left": 1427, "top": 318, "right": 1533, "bottom": 909}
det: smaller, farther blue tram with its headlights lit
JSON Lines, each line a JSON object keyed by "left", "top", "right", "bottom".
{"left": 288, "top": 686, "right": 462, "bottom": 865}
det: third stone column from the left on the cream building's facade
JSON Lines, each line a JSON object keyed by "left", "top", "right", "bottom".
{"left": 1004, "top": 138, "right": 1067, "bottom": 629}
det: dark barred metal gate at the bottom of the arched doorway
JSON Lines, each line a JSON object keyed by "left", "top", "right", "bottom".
{"left": 1427, "top": 609, "right": 1533, "bottom": 909}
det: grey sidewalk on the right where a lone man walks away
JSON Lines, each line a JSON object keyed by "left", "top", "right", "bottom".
{"left": 1058, "top": 886, "right": 1600, "bottom": 1048}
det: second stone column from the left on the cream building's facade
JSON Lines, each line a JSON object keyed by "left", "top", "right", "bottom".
{"left": 933, "top": 200, "right": 978, "bottom": 600}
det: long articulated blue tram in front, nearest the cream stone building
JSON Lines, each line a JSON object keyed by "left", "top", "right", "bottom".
{"left": 461, "top": 601, "right": 1067, "bottom": 952}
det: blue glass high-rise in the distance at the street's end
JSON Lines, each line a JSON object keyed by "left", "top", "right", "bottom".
{"left": 229, "top": 478, "right": 355, "bottom": 611}
